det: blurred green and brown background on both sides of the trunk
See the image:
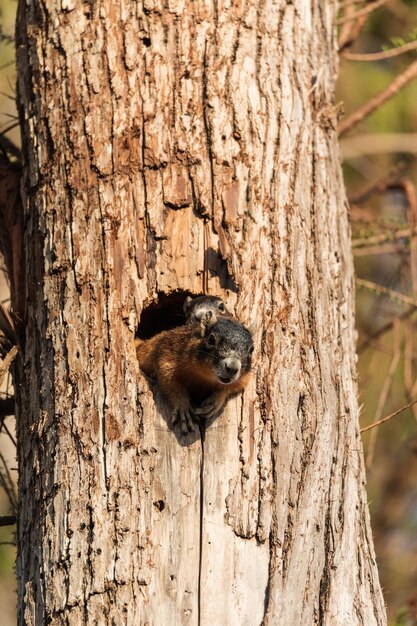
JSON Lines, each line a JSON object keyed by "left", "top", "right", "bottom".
{"left": 0, "top": 0, "right": 417, "bottom": 626}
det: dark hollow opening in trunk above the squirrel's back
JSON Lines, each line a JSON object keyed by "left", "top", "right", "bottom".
{"left": 136, "top": 290, "right": 203, "bottom": 339}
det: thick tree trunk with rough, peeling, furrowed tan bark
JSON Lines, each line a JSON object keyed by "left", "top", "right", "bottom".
{"left": 16, "top": 0, "right": 385, "bottom": 626}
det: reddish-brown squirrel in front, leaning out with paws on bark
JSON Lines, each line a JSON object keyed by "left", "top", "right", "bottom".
{"left": 135, "top": 311, "right": 253, "bottom": 435}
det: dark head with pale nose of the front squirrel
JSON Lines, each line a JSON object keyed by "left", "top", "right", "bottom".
{"left": 200, "top": 317, "right": 253, "bottom": 385}
